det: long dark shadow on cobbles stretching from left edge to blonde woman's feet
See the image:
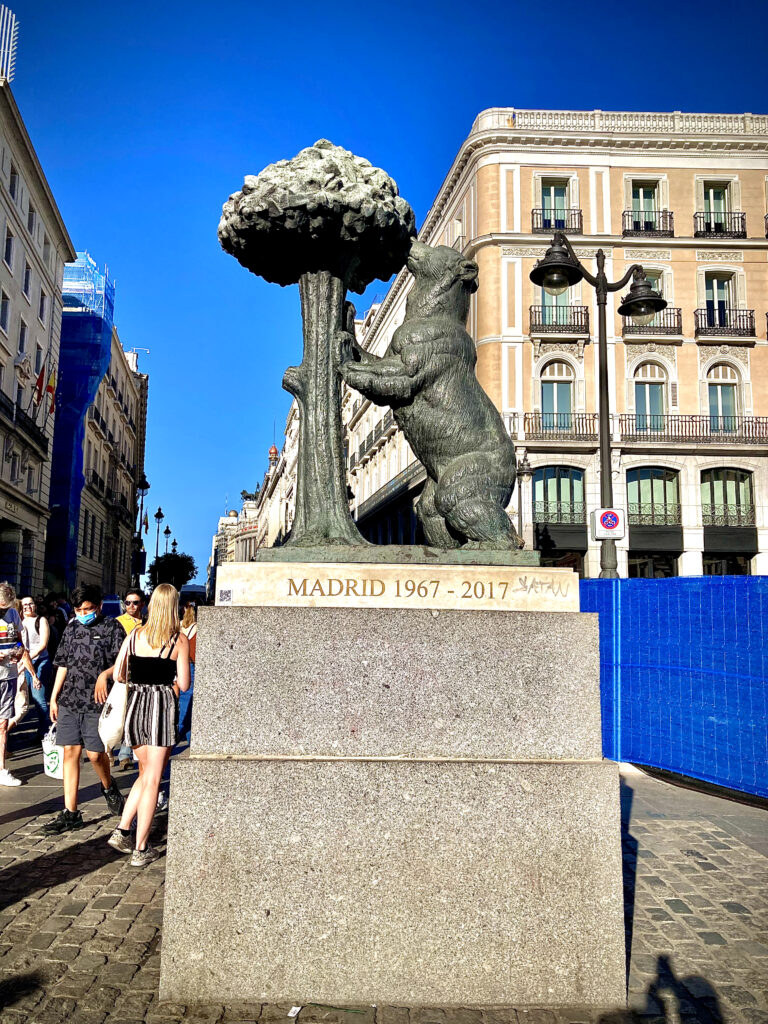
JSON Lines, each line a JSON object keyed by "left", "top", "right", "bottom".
{"left": 0, "top": 831, "right": 122, "bottom": 910}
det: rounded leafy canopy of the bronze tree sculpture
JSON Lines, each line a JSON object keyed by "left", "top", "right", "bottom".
{"left": 218, "top": 139, "right": 416, "bottom": 292}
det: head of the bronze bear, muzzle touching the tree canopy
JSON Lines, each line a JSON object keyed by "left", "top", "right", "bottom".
{"left": 406, "top": 242, "right": 477, "bottom": 324}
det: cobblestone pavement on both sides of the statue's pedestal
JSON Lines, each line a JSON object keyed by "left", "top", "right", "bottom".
{"left": 0, "top": 724, "right": 768, "bottom": 1024}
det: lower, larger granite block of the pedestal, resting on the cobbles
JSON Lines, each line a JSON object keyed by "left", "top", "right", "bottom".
{"left": 161, "top": 758, "right": 625, "bottom": 1007}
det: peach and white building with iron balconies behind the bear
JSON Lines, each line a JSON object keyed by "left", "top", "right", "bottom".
{"left": 343, "top": 108, "right": 768, "bottom": 577}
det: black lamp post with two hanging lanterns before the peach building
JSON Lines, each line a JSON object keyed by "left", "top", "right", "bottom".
{"left": 530, "top": 231, "right": 667, "bottom": 580}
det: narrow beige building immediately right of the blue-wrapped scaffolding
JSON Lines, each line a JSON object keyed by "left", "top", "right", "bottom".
{"left": 76, "top": 328, "right": 146, "bottom": 597}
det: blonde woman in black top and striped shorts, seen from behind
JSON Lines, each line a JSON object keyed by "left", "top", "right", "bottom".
{"left": 108, "top": 583, "right": 189, "bottom": 867}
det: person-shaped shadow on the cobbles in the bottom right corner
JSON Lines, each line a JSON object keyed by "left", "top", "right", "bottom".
{"left": 597, "top": 955, "right": 724, "bottom": 1024}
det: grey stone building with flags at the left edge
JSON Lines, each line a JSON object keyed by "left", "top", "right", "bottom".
{"left": 0, "top": 78, "right": 75, "bottom": 594}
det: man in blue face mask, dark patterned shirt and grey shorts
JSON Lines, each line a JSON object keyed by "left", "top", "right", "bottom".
{"left": 43, "top": 584, "right": 125, "bottom": 835}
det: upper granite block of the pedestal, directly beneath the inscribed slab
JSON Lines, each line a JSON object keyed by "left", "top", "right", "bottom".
{"left": 191, "top": 608, "right": 601, "bottom": 760}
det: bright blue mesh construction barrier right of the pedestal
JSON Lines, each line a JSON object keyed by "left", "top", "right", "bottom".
{"left": 580, "top": 577, "right": 768, "bottom": 797}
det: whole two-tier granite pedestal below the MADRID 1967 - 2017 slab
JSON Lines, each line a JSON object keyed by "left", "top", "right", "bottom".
{"left": 161, "top": 607, "right": 625, "bottom": 1008}
